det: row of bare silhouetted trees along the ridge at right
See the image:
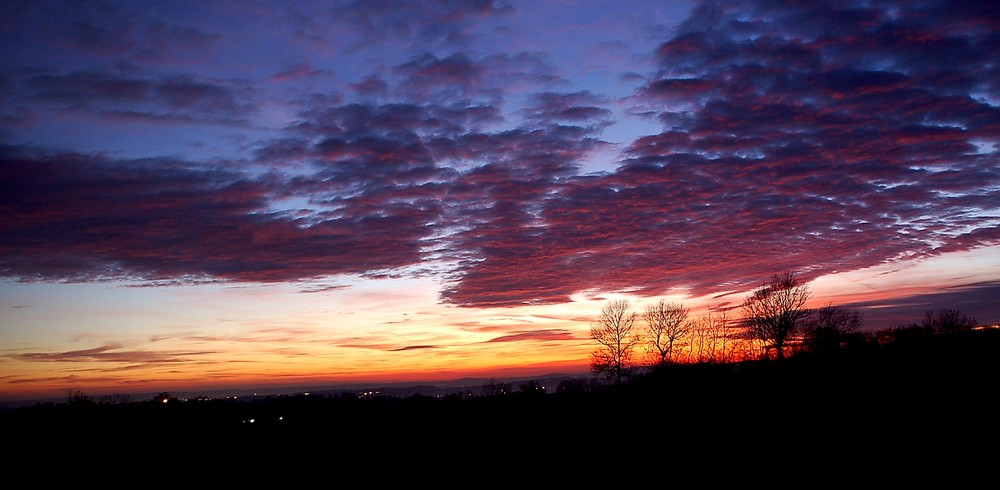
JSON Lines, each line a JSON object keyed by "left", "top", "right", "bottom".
{"left": 590, "top": 273, "right": 978, "bottom": 384}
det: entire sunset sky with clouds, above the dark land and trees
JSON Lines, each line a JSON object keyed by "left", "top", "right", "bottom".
{"left": 0, "top": 0, "right": 1000, "bottom": 400}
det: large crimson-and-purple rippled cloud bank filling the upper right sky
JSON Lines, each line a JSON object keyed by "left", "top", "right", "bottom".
{"left": 444, "top": 2, "right": 1000, "bottom": 306}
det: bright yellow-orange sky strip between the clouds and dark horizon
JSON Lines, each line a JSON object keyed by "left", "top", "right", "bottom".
{"left": 0, "top": 245, "right": 996, "bottom": 400}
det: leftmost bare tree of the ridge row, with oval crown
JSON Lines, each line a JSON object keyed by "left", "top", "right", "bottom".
{"left": 590, "top": 299, "right": 642, "bottom": 384}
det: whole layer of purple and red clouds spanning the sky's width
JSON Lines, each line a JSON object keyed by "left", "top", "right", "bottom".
{"left": 0, "top": 1, "right": 1000, "bottom": 306}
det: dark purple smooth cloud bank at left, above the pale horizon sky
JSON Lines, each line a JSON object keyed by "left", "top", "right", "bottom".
{"left": 0, "top": 147, "right": 438, "bottom": 282}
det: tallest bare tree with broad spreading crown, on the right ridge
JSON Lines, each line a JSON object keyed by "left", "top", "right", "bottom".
{"left": 743, "top": 272, "right": 812, "bottom": 359}
